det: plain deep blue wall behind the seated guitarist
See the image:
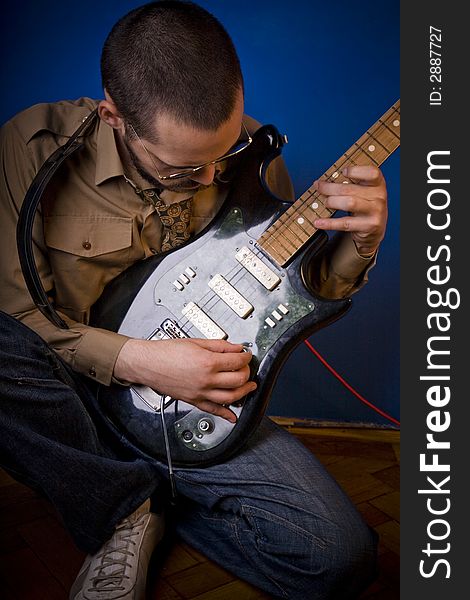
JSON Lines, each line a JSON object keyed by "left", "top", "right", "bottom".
{"left": 0, "top": 0, "right": 400, "bottom": 424}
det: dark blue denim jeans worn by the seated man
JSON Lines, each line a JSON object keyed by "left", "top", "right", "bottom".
{"left": 0, "top": 313, "right": 377, "bottom": 600}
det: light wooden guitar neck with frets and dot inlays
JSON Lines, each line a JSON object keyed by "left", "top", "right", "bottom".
{"left": 257, "top": 101, "right": 400, "bottom": 266}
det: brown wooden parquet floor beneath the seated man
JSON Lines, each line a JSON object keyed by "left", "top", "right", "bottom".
{"left": 0, "top": 419, "right": 400, "bottom": 600}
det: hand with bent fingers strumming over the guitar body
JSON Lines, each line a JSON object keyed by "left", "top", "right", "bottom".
{"left": 114, "top": 338, "right": 256, "bottom": 423}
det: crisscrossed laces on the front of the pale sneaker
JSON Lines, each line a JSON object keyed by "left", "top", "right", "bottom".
{"left": 89, "top": 518, "right": 143, "bottom": 592}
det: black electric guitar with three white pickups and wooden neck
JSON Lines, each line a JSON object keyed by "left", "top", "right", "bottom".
{"left": 91, "top": 102, "right": 400, "bottom": 467}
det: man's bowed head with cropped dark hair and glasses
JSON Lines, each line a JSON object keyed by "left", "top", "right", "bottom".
{"left": 100, "top": 0, "right": 243, "bottom": 189}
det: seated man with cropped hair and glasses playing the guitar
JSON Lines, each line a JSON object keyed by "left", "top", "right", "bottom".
{"left": 0, "top": 1, "right": 387, "bottom": 600}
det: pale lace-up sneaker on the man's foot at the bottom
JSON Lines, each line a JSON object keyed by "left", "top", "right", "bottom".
{"left": 69, "top": 500, "right": 164, "bottom": 600}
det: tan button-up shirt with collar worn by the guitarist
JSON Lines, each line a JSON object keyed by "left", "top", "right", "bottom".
{"left": 0, "top": 98, "right": 373, "bottom": 385}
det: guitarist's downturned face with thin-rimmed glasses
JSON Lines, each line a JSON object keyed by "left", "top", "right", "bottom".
{"left": 123, "top": 93, "right": 243, "bottom": 192}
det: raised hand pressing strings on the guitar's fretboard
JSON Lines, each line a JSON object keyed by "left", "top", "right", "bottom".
{"left": 314, "top": 165, "right": 387, "bottom": 256}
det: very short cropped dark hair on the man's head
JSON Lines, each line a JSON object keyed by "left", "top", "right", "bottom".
{"left": 101, "top": 0, "right": 243, "bottom": 140}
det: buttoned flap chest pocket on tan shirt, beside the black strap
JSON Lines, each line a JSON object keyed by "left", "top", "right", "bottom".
{"left": 44, "top": 215, "right": 133, "bottom": 320}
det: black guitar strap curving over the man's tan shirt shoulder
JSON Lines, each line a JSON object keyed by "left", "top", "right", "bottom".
{"left": 16, "top": 108, "right": 98, "bottom": 329}
